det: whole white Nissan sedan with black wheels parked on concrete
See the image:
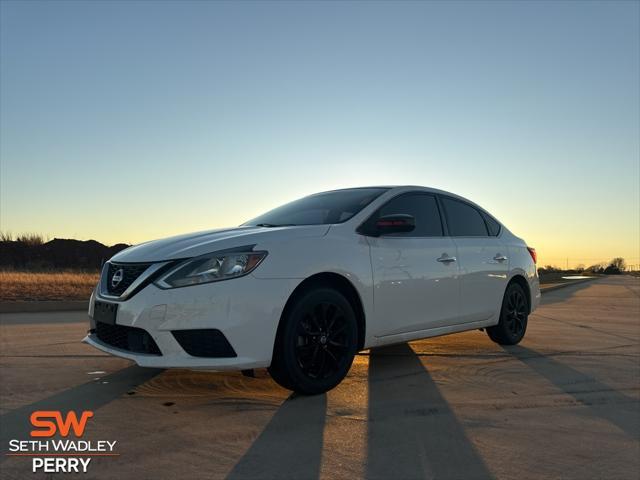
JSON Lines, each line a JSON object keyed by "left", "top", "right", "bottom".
{"left": 84, "top": 186, "right": 540, "bottom": 394}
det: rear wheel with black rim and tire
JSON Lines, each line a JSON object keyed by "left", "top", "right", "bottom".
{"left": 487, "top": 283, "right": 529, "bottom": 345}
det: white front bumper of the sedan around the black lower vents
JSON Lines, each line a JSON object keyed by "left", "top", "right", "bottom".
{"left": 83, "top": 275, "right": 299, "bottom": 370}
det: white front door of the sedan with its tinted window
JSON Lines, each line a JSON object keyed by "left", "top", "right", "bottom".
{"left": 368, "top": 192, "right": 459, "bottom": 343}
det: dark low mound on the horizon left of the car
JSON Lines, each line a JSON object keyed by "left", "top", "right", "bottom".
{"left": 0, "top": 233, "right": 129, "bottom": 270}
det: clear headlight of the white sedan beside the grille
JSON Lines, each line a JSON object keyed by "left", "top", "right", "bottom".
{"left": 154, "top": 252, "right": 267, "bottom": 288}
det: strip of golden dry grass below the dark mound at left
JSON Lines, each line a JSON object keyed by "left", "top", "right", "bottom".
{"left": 0, "top": 271, "right": 99, "bottom": 301}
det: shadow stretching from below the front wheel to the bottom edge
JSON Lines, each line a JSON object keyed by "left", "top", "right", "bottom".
{"left": 227, "top": 394, "right": 327, "bottom": 480}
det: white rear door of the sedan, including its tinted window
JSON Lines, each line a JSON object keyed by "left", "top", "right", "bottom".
{"left": 440, "top": 196, "right": 509, "bottom": 322}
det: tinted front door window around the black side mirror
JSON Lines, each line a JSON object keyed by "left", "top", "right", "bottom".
{"left": 374, "top": 193, "right": 443, "bottom": 237}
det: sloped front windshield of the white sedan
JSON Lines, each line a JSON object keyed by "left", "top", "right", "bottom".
{"left": 243, "top": 188, "right": 388, "bottom": 227}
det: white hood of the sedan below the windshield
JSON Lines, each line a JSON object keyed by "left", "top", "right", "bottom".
{"left": 111, "top": 225, "right": 330, "bottom": 263}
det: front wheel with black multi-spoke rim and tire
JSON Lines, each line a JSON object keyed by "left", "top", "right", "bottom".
{"left": 269, "top": 287, "right": 358, "bottom": 395}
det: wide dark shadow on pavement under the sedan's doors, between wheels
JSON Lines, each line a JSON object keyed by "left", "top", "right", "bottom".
{"left": 366, "top": 344, "right": 492, "bottom": 480}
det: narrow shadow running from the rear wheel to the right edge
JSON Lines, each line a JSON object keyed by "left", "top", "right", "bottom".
{"left": 503, "top": 345, "right": 640, "bottom": 440}
